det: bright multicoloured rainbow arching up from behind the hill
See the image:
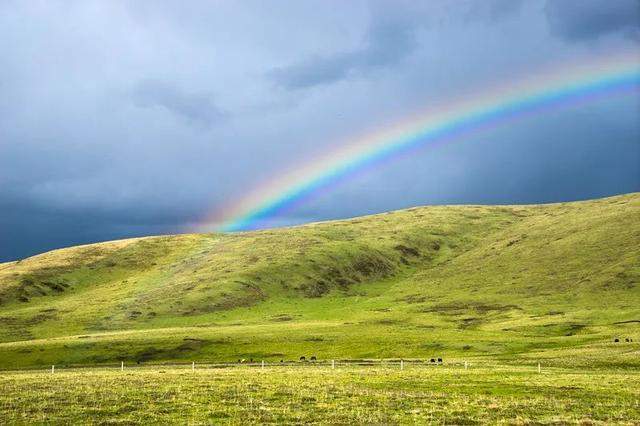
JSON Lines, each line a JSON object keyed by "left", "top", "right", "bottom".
{"left": 204, "top": 51, "right": 640, "bottom": 232}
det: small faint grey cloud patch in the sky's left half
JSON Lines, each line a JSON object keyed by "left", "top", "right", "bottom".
{"left": 133, "top": 80, "right": 225, "bottom": 126}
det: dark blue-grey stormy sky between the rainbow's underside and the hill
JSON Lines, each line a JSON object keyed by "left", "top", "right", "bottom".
{"left": 296, "top": 99, "right": 640, "bottom": 223}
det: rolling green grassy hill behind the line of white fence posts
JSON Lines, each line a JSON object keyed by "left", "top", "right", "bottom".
{"left": 0, "top": 193, "right": 640, "bottom": 369}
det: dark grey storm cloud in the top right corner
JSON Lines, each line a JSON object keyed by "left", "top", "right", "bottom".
{"left": 545, "top": 0, "right": 640, "bottom": 41}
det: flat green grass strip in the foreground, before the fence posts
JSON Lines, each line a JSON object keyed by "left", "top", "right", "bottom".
{"left": 0, "top": 364, "right": 640, "bottom": 424}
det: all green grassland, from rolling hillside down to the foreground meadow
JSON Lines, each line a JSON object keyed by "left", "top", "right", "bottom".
{"left": 0, "top": 193, "right": 640, "bottom": 423}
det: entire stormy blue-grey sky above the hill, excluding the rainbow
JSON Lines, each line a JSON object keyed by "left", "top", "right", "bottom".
{"left": 0, "top": 0, "right": 640, "bottom": 261}
